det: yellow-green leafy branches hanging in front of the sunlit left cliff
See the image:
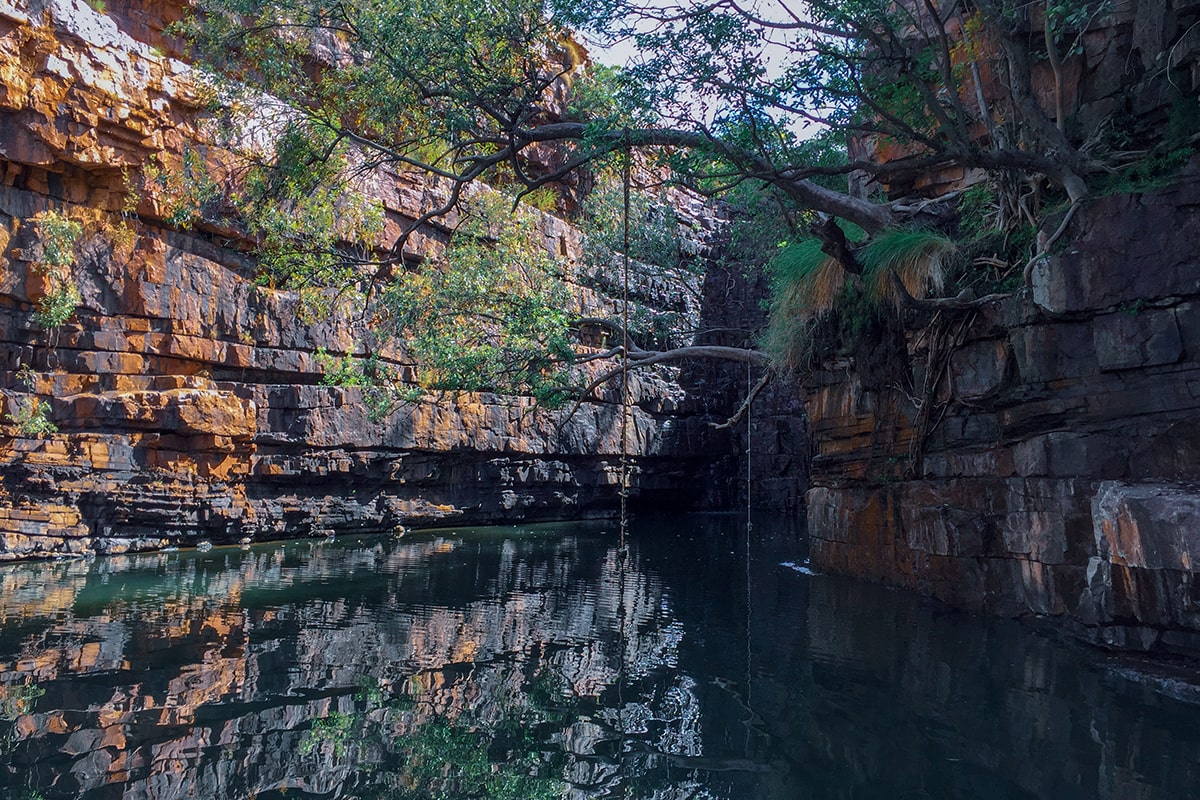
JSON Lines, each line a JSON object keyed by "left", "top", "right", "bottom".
{"left": 166, "top": 0, "right": 609, "bottom": 407}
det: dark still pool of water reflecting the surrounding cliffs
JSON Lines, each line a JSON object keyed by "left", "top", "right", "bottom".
{"left": 0, "top": 517, "right": 1200, "bottom": 800}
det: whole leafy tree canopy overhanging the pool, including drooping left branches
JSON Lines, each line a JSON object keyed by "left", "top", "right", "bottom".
{"left": 174, "top": 0, "right": 1195, "bottom": 407}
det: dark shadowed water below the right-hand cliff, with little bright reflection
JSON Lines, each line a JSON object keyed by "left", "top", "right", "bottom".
{"left": 640, "top": 525, "right": 1200, "bottom": 800}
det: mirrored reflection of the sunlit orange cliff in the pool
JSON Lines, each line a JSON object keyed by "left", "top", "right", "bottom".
{"left": 0, "top": 525, "right": 696, "bottom": 799}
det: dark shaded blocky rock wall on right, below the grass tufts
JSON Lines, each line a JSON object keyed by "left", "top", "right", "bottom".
{"left": 808, "top": 183, "right": 1200, "bottom": 654}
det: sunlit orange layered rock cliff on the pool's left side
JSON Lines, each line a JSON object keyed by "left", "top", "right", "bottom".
{"left": 0, "top": 0, "right": 748, "bottom": 559}
